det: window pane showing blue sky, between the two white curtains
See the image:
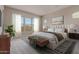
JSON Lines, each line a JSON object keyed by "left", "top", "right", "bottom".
{"left": 22, "top": 17, "right": 33, "bottom": 32}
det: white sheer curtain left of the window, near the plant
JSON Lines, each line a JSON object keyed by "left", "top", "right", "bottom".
{"left": 12, "top": 14, "right": 21, "bottom": 34}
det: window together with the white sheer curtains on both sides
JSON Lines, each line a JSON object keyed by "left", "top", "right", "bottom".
{"left": 12, "top": 14, "right": 40, "bottom": 33}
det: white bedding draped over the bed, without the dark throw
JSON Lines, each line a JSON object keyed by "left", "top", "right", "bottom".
{"left": 32, "top": 32, "right": 66, "bottom": 49}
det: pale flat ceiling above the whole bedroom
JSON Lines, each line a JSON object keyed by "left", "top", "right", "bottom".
{"left": 8, "top": 5, "right": 69, "bottom": 16}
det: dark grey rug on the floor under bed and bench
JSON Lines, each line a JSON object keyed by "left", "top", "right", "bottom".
{"left": 33, "top": 40, "right": 76, "bottom": 54}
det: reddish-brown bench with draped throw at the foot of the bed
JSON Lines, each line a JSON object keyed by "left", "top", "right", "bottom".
{"left": 28, "top": 36, "right": 49, "bottom": 47}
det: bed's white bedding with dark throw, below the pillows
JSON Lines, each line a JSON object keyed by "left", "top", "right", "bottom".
{"left": 29, "top": 32, "right": 67, "bottom": 50}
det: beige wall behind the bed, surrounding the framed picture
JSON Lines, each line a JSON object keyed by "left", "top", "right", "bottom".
{"left": 42, "top": 5, "right": 79, "bottom": 30}
